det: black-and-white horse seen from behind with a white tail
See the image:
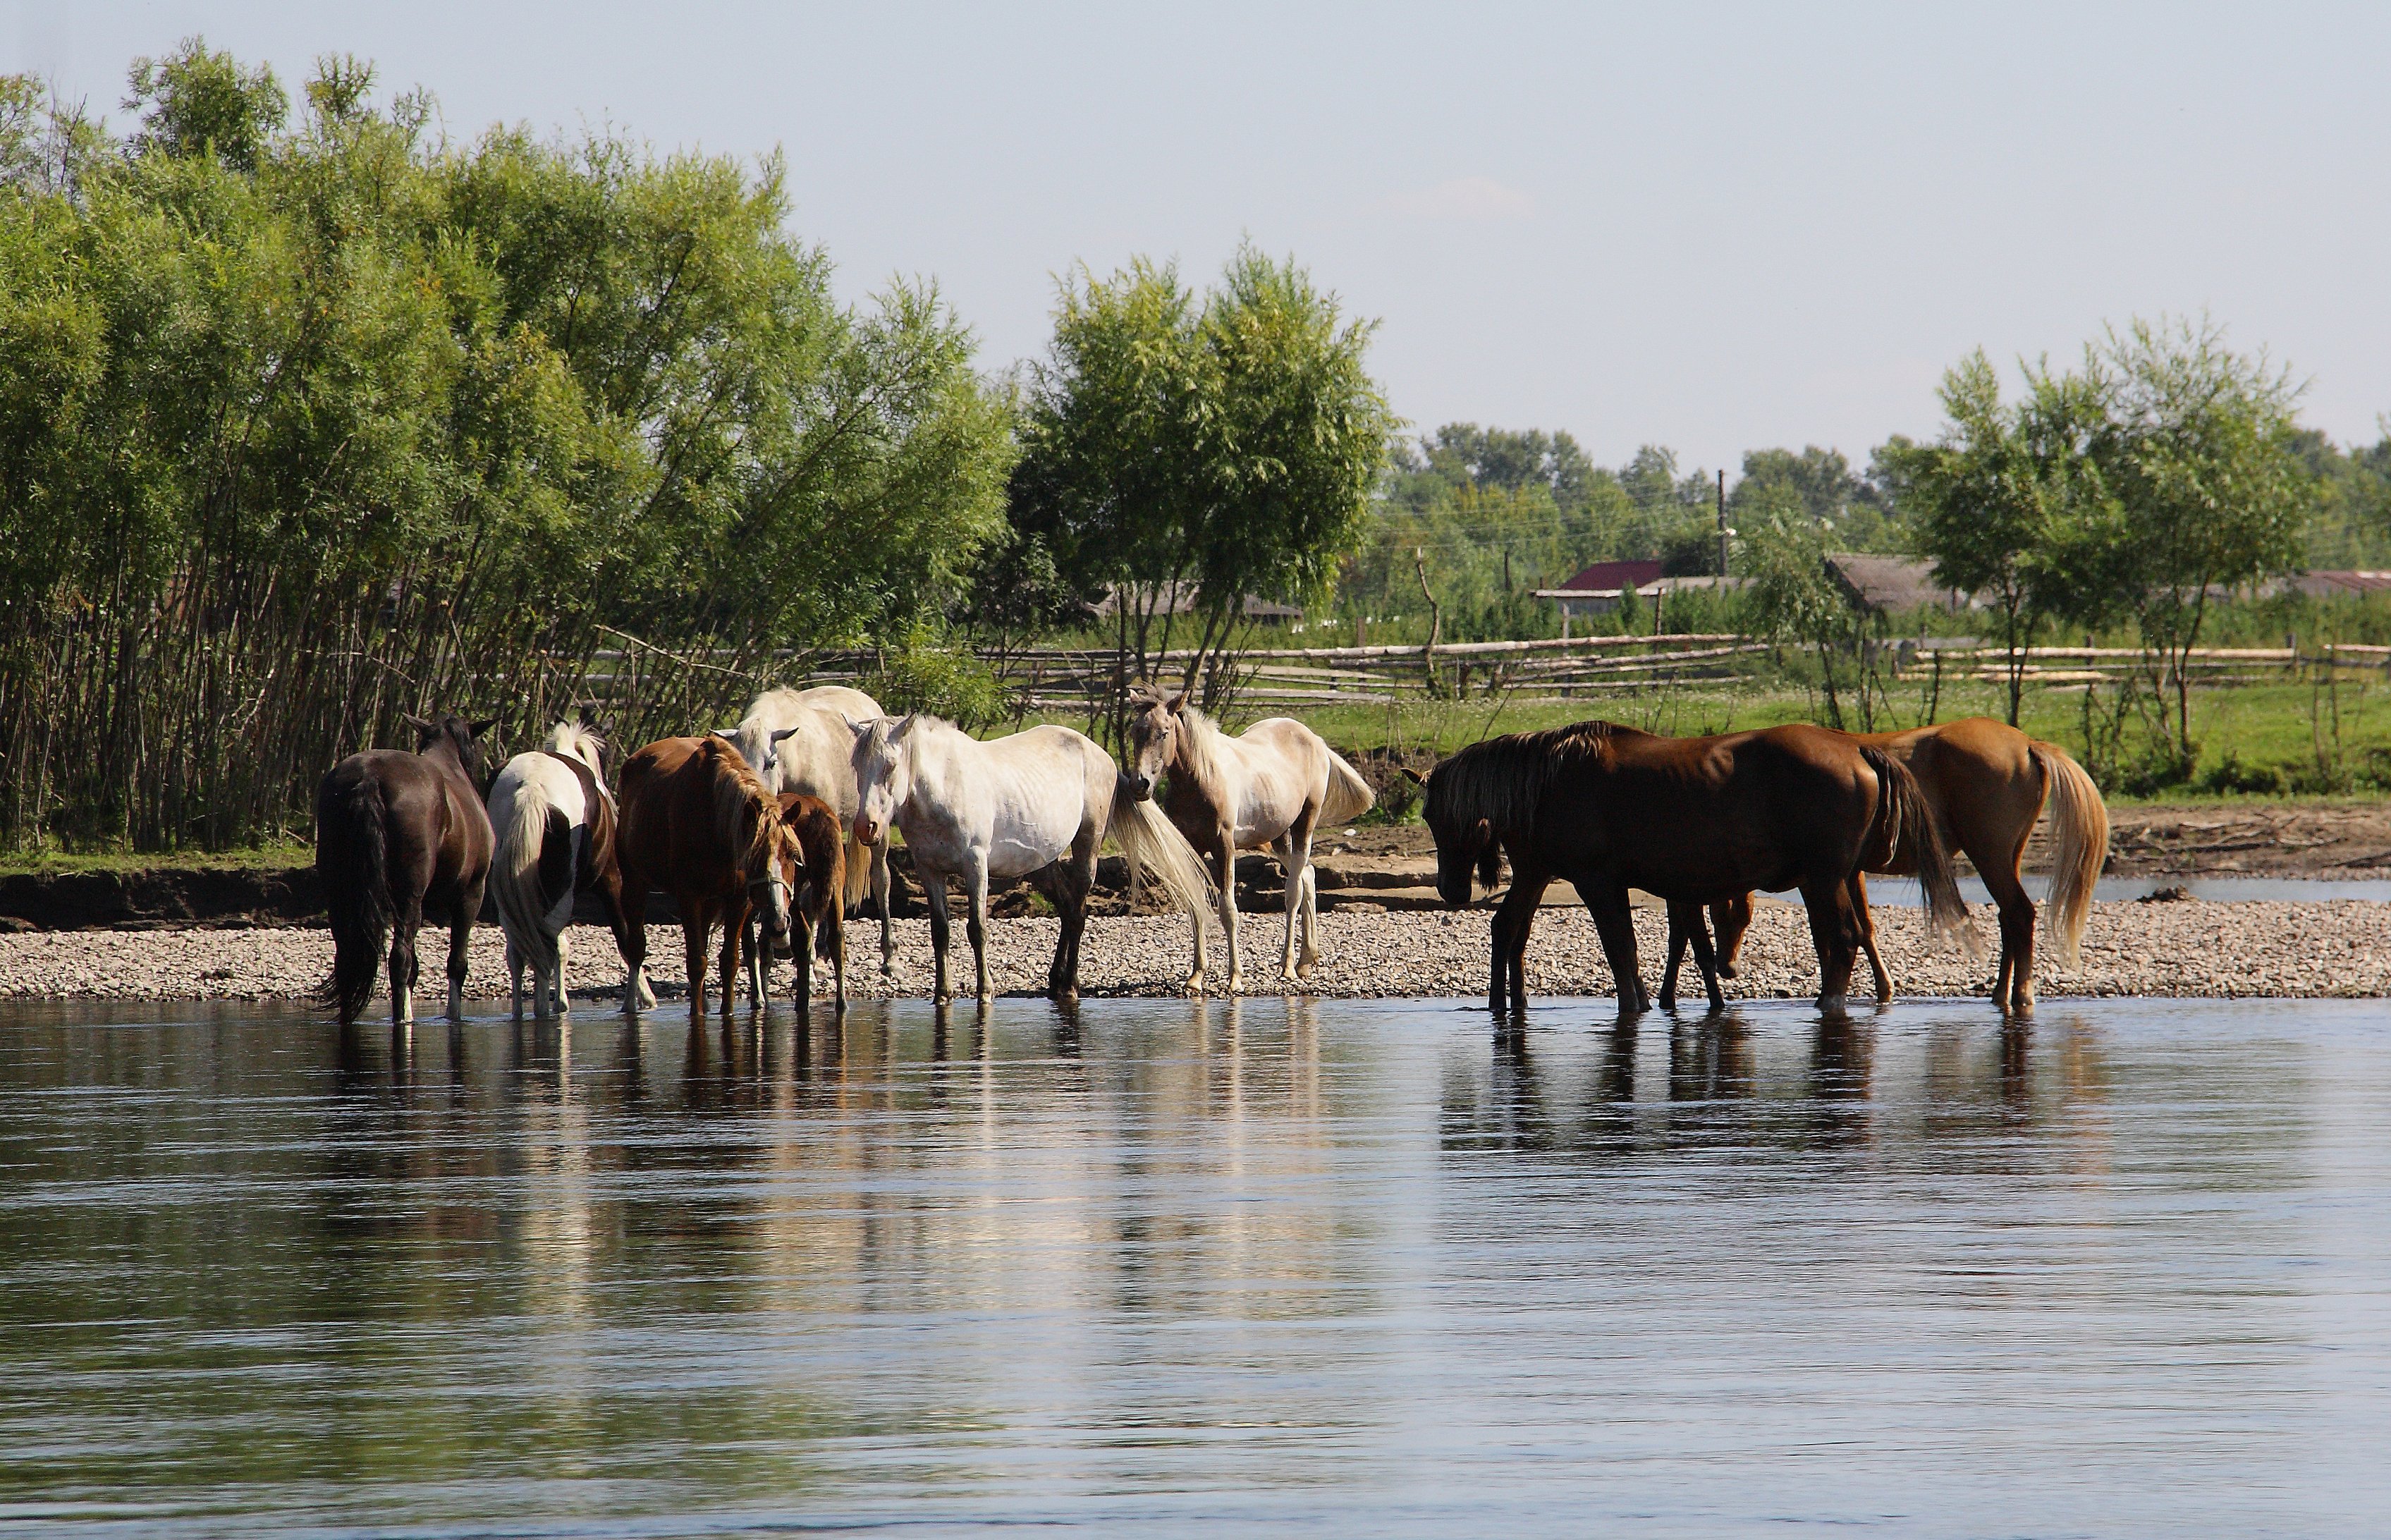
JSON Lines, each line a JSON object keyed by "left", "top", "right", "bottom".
{"left": 490, "top": 722, "right": 655, "bottom": 1021}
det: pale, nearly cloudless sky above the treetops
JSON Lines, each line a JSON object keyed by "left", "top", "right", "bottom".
{"left": 0, "top": 0, "right": 2391, "bottom": 469}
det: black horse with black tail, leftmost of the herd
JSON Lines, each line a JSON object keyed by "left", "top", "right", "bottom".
{"left": 316, "top": 715, "right": 497, "bottom": 1026}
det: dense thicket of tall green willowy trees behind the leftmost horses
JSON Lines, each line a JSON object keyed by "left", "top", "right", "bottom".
{"left": 0, "top": 41, "right": 1014, "bottom": 849}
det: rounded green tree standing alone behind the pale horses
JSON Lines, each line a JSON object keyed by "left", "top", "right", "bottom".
{"left": 1011, "top": 246, "right": 1396, "bottom": 707}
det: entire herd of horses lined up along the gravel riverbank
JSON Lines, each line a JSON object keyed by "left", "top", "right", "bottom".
{"left": 316, "top": 686, "right": 2109, "bottom": 1026}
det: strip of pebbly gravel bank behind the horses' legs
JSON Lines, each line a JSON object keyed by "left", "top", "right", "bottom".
{"left": 0, "top": 902, "right": 2391, "bottom": 1014}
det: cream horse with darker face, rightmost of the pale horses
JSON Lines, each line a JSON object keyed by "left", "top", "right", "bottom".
{"left": 1129, "top": 689, "right": 1377, "bottom": 992}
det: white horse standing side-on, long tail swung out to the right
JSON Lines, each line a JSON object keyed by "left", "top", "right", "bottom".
{"left": 854, "top": 713, "right": 1205, "bottom": 1009}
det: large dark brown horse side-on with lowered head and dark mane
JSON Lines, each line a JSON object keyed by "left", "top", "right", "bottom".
{"left": 1425, "top": 722, "right": 1968, "bottom": 1012}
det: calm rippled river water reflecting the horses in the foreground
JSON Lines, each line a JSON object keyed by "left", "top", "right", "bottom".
{"left": 0, "top": 1000, "right": 2391, "bottom": 1535}
